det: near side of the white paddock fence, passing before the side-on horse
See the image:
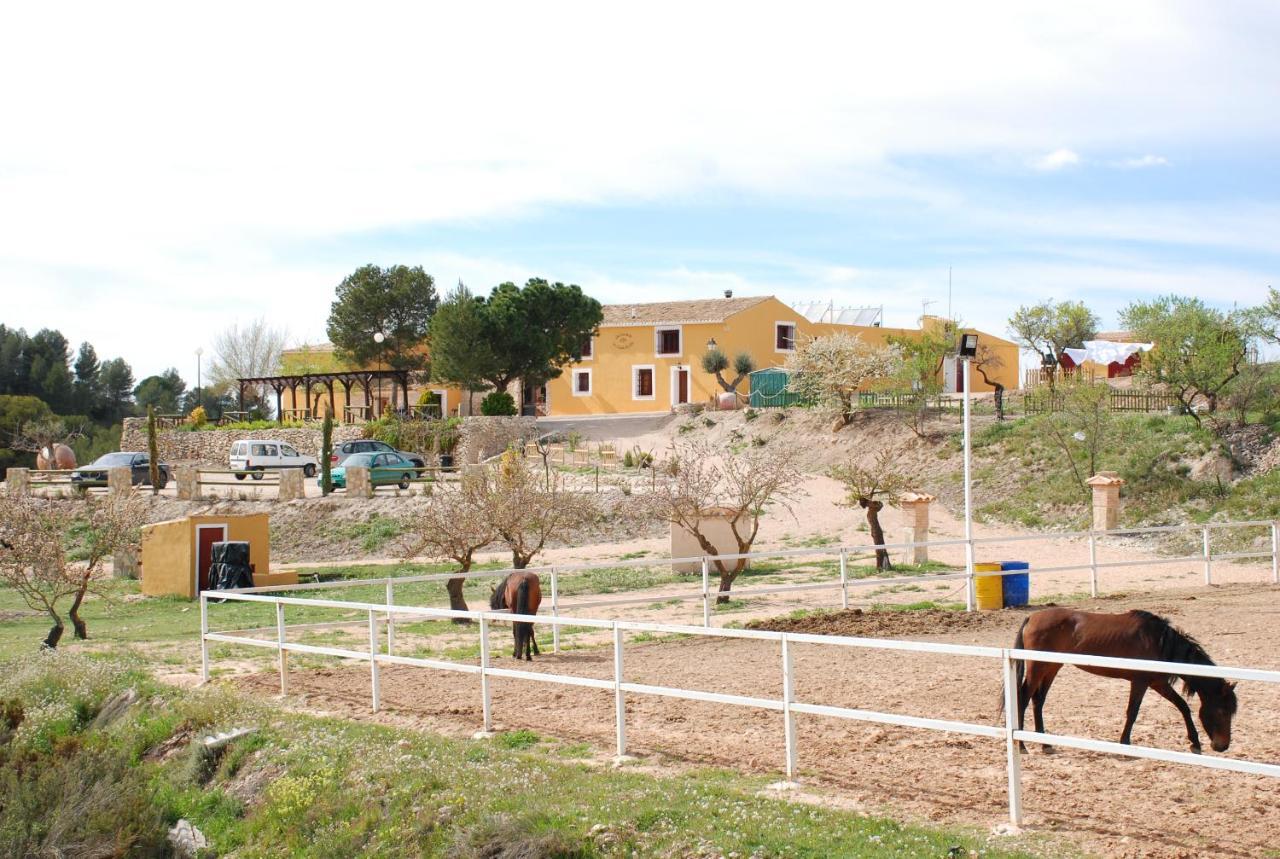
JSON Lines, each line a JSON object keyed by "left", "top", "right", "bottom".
{"left": 200, "top": 570, "right": 1280, "bottom": 824}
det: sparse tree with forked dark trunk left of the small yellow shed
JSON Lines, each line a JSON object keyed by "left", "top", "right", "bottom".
{"left": 0, "top": 495, "right": 147, "bottom": 648}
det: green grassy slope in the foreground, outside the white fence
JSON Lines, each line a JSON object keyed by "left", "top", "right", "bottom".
{"left": 0, "top": 654, "right": 1034, "bottom": 859}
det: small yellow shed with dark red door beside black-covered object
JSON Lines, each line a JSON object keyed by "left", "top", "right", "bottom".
{"left": 142, "top": 513, "right": 298, "bottom": 599}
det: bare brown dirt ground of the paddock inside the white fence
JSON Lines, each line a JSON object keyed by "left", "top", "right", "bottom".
{"left": 238, "top": 584, "right": 1280, "bottom": 856}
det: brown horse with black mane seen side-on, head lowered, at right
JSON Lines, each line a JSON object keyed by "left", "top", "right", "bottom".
{"left": 1014, "top": 608, "right": 1236, "bottom": 754}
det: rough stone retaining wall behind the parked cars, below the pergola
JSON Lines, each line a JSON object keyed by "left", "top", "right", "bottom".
{"left": 120, "top": 416, "right": 538, "bottom": 469}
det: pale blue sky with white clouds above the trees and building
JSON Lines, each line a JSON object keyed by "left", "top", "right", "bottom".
{"left": 0, "top": 0, "right": 1280, "bottom": 381}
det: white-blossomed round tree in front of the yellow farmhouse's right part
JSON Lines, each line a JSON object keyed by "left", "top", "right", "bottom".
{"left": 787, "top": 333, "right": 902, "bottom": 429}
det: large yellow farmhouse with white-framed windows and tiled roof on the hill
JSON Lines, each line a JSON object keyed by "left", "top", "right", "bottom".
{"left": 542, "top": 296, "right": 1018, "bottom": 417}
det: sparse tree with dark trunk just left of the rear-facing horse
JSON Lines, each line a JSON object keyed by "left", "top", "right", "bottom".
{"left": 404, "top": 475, "right": 498, "bottom": 623}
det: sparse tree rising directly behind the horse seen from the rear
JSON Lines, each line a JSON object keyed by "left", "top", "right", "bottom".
{"left": 481, "top": 449, "right": 600, "bottom": 570}
